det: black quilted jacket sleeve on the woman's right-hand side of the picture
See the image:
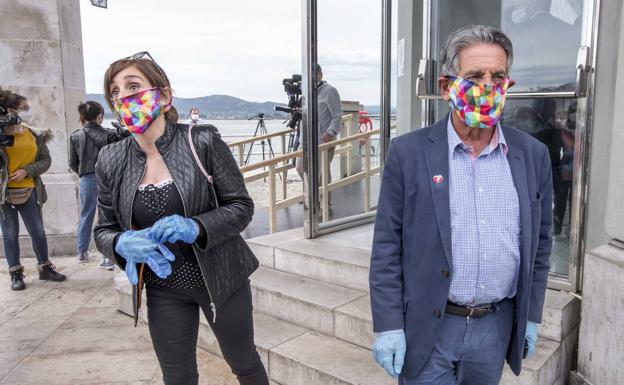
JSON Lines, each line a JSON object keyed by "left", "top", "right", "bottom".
{"left": 194, "top": 127, "right": 254, "bottom": 251}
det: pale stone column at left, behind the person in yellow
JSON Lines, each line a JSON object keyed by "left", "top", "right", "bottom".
{"left": 0, "top": 0, "right": 85, "bottom": 256}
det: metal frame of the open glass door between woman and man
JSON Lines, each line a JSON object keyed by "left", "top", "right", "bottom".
{"left": 301, "top": 0, "right": 392, "bottom": 238}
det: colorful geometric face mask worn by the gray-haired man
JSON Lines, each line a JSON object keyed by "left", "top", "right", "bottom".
{"left": 446, "top": 75, "right": 511, "bottom": 128}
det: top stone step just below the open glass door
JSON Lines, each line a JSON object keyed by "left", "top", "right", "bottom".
{"left": 274, "top": 239, "right": 370, "bottom": 291}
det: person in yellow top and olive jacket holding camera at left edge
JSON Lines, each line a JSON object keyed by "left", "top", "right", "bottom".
{"left": 0, "top": 89, "right": 65, "bottom": 290}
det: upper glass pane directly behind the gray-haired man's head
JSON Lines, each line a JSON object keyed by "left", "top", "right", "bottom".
{"left": 431, "top": 0, "right": 583, "bottom": 92}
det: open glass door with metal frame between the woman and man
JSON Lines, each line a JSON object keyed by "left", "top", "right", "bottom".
{"left": 299, "top": 0, "right": 391, "bottom": 238}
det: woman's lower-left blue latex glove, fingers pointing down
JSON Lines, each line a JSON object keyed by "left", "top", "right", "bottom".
{"left": 115, "top": 229, "right": 175, "bottom": 285}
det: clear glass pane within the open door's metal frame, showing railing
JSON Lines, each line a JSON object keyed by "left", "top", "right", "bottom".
{"left": 315, "top": 0, "right": 381, "bottom": 225}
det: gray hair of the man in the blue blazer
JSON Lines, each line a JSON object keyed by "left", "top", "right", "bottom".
{"left": 440, "top": 25, "right": 513, "bottom": 76}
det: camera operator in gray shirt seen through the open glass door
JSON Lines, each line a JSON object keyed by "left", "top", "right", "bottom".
{"left": 296, "top": 64, "right": 342, "bottom": 187}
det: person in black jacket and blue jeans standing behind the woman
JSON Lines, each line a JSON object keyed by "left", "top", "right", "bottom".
{"left": 69, "top": 100, "right": 129, "bottom": 270}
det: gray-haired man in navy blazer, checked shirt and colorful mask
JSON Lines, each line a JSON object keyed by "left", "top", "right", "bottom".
{"left": 370, "top": 26, "right": 553, "bottom": 385}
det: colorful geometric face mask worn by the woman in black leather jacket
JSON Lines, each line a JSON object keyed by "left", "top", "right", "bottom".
{"left": 113, "top": 88, "right": 166, "bottom": 135}
